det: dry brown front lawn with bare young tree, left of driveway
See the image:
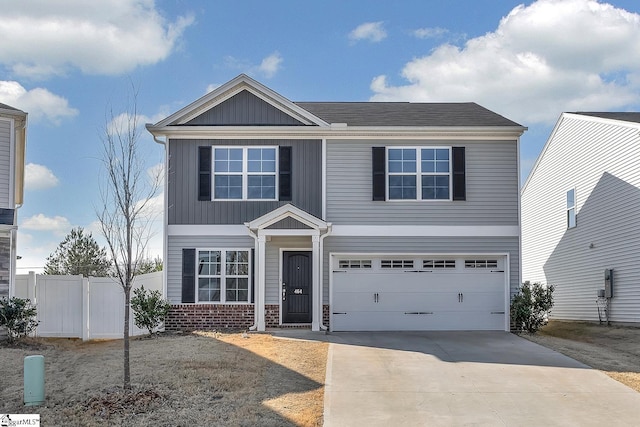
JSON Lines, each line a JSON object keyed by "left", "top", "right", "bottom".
{"left": 0, "top": 332, "right": 328, "bottom": 426}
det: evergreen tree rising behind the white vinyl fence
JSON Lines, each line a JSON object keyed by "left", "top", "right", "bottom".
{"left": 44, "top": 227, "right": 111, "bottom": 277}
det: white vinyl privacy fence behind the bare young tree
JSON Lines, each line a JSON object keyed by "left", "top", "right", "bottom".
{"left": 15, "top": 271, "right": 163, "bottom": 341}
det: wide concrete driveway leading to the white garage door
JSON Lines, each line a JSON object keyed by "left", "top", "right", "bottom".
{"left": 324, "top": 332, "right": 640, "bottom": 427}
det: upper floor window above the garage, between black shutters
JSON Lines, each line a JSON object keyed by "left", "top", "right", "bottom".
{"left": 387, "top": 147, "right": 451, "bottom": 200}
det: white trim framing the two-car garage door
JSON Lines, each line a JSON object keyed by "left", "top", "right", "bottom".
{"left": 329, "top": 252, "right": 511, "bottom": 332}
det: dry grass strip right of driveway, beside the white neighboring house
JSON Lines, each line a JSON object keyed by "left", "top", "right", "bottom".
{"left": 523, "top": 321, "right": 640, "bottom": 391}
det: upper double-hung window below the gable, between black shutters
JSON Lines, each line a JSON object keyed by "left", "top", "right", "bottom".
{"left": 213, "top": 146, "right": 278, "bottom": 200}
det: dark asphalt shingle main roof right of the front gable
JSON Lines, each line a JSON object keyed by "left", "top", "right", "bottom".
{"left": 295, "top": 102, "right": 522, "bottom": 127}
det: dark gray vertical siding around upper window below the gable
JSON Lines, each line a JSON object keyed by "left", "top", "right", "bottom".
{"left": 167, "top": 139, "right": 322, "bottom": 224}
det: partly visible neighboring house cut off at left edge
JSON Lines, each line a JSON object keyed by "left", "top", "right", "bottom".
{"left": 0, "top": 103, "right": 27, "bottom": 298}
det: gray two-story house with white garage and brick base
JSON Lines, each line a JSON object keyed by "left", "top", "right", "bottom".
{"left": 147, "top": 75, "right": 525, "bottom": 331}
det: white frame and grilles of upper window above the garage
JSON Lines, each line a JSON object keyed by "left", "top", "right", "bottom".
{"left": 384, "top": 145, "right": 453, "bottom": 202}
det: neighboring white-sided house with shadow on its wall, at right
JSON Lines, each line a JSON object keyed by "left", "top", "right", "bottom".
{"left": 522, "top": 113, "right": 640, "bottom": 322}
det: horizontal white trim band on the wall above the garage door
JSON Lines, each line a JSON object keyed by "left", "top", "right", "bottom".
{"left": 331, "top": 225, "right": 520, "bottom": 237}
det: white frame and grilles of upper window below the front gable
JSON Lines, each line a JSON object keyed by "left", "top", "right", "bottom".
{"left": 211, "top": 145, "right": 280, "bottom": 202}
